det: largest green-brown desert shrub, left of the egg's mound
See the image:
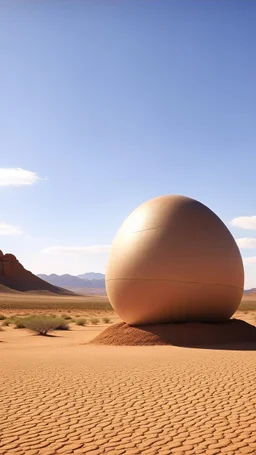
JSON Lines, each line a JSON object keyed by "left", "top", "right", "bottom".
{"left": 23, "top": 316, "right": 68, "bottom": 335}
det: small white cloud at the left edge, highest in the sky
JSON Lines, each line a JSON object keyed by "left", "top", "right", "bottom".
{"left": 0, "top": 168, "right": 39, "bottom": 186}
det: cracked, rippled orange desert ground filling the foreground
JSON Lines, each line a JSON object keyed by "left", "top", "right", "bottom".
{"left": 0, "top": 345, "right": 256, "bottom": 455}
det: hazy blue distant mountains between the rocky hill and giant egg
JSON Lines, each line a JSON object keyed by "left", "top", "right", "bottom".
{"left": 37, "top": 272, "right": 105, "bottom": 294}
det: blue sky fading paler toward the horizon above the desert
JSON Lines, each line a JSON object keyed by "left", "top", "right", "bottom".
{"left": 0, "top": 0, "right": 256, "bottom": 287}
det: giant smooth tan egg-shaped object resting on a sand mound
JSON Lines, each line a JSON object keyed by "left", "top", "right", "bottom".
{"left": 106, "top": 195, "right": 244, "bottom": 325}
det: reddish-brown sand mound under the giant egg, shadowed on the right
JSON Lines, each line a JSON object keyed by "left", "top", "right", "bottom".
{"left": 91, "top": 319, "right": 256, "bottom": 350}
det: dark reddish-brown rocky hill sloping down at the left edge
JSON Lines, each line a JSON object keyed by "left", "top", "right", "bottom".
{"left": 0, "top": 250, "right": 73, "bottom": 295}
